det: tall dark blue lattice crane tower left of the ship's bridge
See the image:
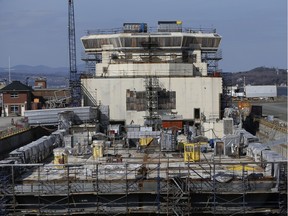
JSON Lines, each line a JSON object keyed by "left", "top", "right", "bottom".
{"left": 68, "top": 0, "right": 81, "bottom": 107}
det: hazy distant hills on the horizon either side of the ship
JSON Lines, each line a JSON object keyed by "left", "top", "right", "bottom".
{"left": 0, "top": 64, "right": 287, "bottom": 88}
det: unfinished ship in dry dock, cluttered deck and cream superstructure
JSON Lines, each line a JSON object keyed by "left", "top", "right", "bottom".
{"left": 0, "top": 21, "right": 287, "bottom": 215}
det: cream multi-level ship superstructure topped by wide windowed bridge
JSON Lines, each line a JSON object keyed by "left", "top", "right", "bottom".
{"left": 81, "top": 21, "right": 222, "bottom": 132}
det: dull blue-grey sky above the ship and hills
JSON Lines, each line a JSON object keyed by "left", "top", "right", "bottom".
{"left": 0, "top": 0, "right": 287, "bottom": 72}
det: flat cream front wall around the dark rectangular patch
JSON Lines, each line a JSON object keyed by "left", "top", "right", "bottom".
{"left": 82, "top": 77, "right": 222, "bottom": 125}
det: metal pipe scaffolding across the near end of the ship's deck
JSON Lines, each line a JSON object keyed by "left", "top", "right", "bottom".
{"left": 0, "top": 158, "right": 287, "bottom": 215}
